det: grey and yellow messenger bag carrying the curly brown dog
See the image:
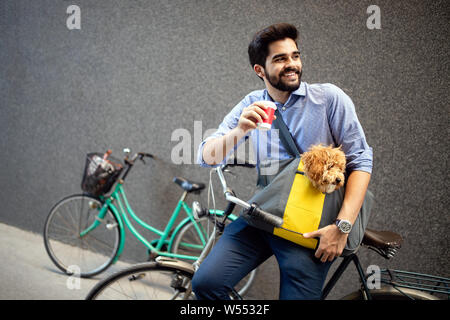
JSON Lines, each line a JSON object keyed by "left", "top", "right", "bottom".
{"left": 241, "top": 110, "right": 374, "bottom": 256}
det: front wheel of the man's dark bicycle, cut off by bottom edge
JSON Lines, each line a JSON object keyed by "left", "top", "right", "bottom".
{"left": 86, "top": 260, "right": 194, "bottom": 300}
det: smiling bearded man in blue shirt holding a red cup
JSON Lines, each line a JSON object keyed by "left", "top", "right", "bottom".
{"left": 192, "top": 23, "right": 372, "bottom": 299}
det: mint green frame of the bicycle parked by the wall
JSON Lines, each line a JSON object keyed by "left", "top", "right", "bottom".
{"left": 80, "top": 180, "right": 237, "bottom": 263}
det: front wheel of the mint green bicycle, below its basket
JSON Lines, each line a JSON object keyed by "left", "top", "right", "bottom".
{"left": 43, "top": 194, "right": 121, "bottom": 278}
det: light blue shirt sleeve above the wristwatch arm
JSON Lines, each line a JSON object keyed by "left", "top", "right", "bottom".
{"left": 327, "top": 85, "right": 373, "bottom": 173}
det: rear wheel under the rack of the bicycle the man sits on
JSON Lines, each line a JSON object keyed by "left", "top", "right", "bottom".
{"left": 341, "top": 286, "right": 439, "bottom": 300}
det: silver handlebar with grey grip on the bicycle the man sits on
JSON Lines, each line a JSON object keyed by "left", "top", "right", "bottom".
{"left": 215, "top": 163, "right": 283, "bottom": 228}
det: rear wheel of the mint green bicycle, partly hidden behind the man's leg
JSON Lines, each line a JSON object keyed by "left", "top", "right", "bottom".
{"left": 172, "top": 216, "right": 257, "bottom": 296}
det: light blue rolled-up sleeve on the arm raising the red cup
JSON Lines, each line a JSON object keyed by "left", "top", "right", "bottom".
{"left": 197, "top": 97, "right": 250, "bottom": 167}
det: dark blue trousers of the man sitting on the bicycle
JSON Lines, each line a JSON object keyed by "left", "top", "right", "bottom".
{"left": 192, "top": 218, "right": 332, "bottom": 300}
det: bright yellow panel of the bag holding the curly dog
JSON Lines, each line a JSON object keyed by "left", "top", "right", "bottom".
{"left": 273, "top": 161, "right": 325, "bottom": 249}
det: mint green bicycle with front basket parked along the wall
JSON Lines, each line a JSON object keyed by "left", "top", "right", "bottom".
{"left": 44, "top": 149, "right": 255, "bottom": 295}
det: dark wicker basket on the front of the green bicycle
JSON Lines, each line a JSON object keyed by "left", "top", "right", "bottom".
{"left": 81, "top": 153, "right": 123, "bottom": 196}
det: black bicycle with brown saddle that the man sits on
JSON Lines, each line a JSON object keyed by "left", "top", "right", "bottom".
{"left": 86, "top": 163, "right": 450, "bottom": 300}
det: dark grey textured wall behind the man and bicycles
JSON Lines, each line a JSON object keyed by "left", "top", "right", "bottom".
{"left": 0, "top": 0, "right": 450, "bottom": 298}
